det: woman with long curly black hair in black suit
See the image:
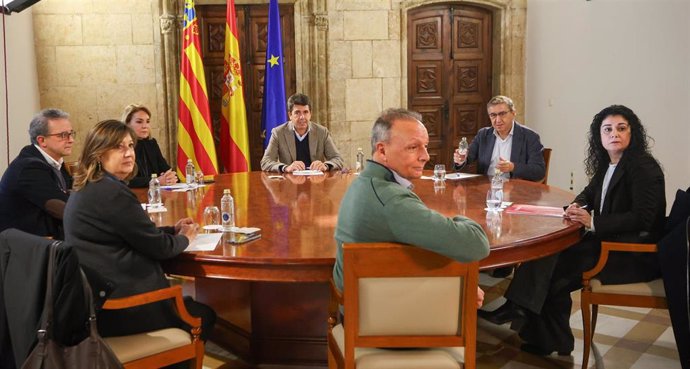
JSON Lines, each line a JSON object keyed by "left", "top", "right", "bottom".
{"left": 480, "top": 105, "right": 666, "bottom": 355}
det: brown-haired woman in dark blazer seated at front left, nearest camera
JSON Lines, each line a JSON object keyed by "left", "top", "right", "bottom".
{"left": 64, "top": 120, "right": 215, "bottom": 338}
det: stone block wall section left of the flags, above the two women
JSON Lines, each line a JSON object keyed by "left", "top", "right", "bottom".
{"left": 32, "top": 0, "right": 168, "bottom": 160}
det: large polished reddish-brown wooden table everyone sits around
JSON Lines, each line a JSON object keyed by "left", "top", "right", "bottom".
{"left": 138, "top": 172, "right": 580, "bottom": 365}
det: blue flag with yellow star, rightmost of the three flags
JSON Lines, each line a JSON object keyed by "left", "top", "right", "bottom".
{"left": 261, "top": 0, "right": 287, "bottom": 148}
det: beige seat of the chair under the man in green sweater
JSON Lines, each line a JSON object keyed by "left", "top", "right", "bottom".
{"left": 332, "top": 324, "right": 464, "bottom": 369}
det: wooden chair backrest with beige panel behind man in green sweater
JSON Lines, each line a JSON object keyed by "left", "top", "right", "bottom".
{"left": 343, "top": 243, "right": 479, "bottom": 366}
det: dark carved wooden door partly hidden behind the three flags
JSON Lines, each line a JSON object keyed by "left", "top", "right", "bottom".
{"left": 196, "top": 4, "right": 297, "bottom": 170}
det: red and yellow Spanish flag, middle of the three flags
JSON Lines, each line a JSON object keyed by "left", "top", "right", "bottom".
{"left": 220, "top": 0, "right": 249, "bottom": 173}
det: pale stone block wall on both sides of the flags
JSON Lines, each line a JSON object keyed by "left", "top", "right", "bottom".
{"left": 34, "top": 0, "right": 527, "bottom": 166}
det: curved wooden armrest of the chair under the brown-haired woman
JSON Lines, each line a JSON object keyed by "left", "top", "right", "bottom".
{"left": 103, "top": 286, "right": 201, "bottom": 334}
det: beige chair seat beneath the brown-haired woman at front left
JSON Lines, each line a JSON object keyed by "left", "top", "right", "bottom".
{"left": 104, "top": 328, "right": 192, "bottom": 363}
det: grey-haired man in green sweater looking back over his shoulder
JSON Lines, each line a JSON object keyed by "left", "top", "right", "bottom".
{"left": 333, "top": 109, "right": 489, "bottom": 306}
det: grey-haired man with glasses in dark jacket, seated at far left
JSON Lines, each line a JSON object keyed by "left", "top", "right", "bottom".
{"left": 0, "top": 109, "right": 76, "bottom": 239}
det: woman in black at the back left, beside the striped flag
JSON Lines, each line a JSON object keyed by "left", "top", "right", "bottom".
{"left": 122, "top": 104, "right": 177, "bottom": 188}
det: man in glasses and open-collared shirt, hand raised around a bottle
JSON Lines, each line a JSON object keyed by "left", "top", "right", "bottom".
{"left": 453, "top": 95, "right": 546, "bottom": 181}
